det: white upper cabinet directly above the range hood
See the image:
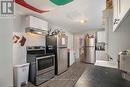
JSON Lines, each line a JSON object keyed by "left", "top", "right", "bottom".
{"left": 26, "top": 16, "right": 48, "bottom": 31}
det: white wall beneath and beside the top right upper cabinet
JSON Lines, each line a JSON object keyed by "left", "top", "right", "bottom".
{"left": 108, "top": 11, "right": 130, "bottom": 61}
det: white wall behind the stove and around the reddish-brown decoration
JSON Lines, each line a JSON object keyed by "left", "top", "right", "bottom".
{"left": 13, "top": 14, "right": 45, "bottom": 65}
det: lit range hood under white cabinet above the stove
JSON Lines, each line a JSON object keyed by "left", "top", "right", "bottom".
{"left": 25, "top": 27, "right": 48, "bottom": 36}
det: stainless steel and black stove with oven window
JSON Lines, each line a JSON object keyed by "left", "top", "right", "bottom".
{"left": 27, "top": 46, "right": 55, "bottom": 85}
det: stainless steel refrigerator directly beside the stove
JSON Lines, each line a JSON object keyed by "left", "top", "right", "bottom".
{"left": 46, "top": 35, "right": 68, "bottom": 75}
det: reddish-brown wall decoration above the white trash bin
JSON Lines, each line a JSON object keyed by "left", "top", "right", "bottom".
{"left": 13, "top": 34, "right": 26, "bottom": 46}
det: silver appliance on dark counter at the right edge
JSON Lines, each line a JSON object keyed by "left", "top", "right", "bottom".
{"left": 118, "top": 50, "right": 130, "bottom": 81}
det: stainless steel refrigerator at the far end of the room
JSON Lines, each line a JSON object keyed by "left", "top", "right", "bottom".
{"left": 80, "top": 34, "right": 96, "bottom": 64}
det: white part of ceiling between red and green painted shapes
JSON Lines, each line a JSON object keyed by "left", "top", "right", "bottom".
{"left": 16, "top": 0, "right": 106, "bottom": 33}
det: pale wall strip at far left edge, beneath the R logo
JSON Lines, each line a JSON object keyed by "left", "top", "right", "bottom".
{"left": 0, "top": 18, "right": 13, "bottom": 87}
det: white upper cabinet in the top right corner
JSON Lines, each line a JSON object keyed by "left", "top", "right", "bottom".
{"left": 113, "top": 0, "right": 130, "bottom": 31}
